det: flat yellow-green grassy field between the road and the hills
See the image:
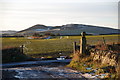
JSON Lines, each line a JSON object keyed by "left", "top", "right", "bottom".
{"left": 2, "top": 35, "right": 120, "bottom": 57}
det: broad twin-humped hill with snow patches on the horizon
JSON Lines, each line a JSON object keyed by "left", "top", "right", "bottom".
{"left": 17, "top": 24, "right": 120, "bottom": 35}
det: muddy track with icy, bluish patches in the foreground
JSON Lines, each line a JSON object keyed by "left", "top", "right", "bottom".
{"left": 1, "top": 61, "right": 98, "bottom": 80}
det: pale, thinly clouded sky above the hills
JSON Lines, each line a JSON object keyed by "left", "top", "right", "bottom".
{"left": 0, "top": 0, "right": 119, "bottom": 31}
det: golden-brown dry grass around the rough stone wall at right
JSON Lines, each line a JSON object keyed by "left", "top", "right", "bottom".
{"left": 67, "top": 44, "right": 120, "bottom": 80}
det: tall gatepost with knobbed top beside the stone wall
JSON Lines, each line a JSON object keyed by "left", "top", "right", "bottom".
{"left": 80, "top": 32, "right": 86, "bottom": 54}
